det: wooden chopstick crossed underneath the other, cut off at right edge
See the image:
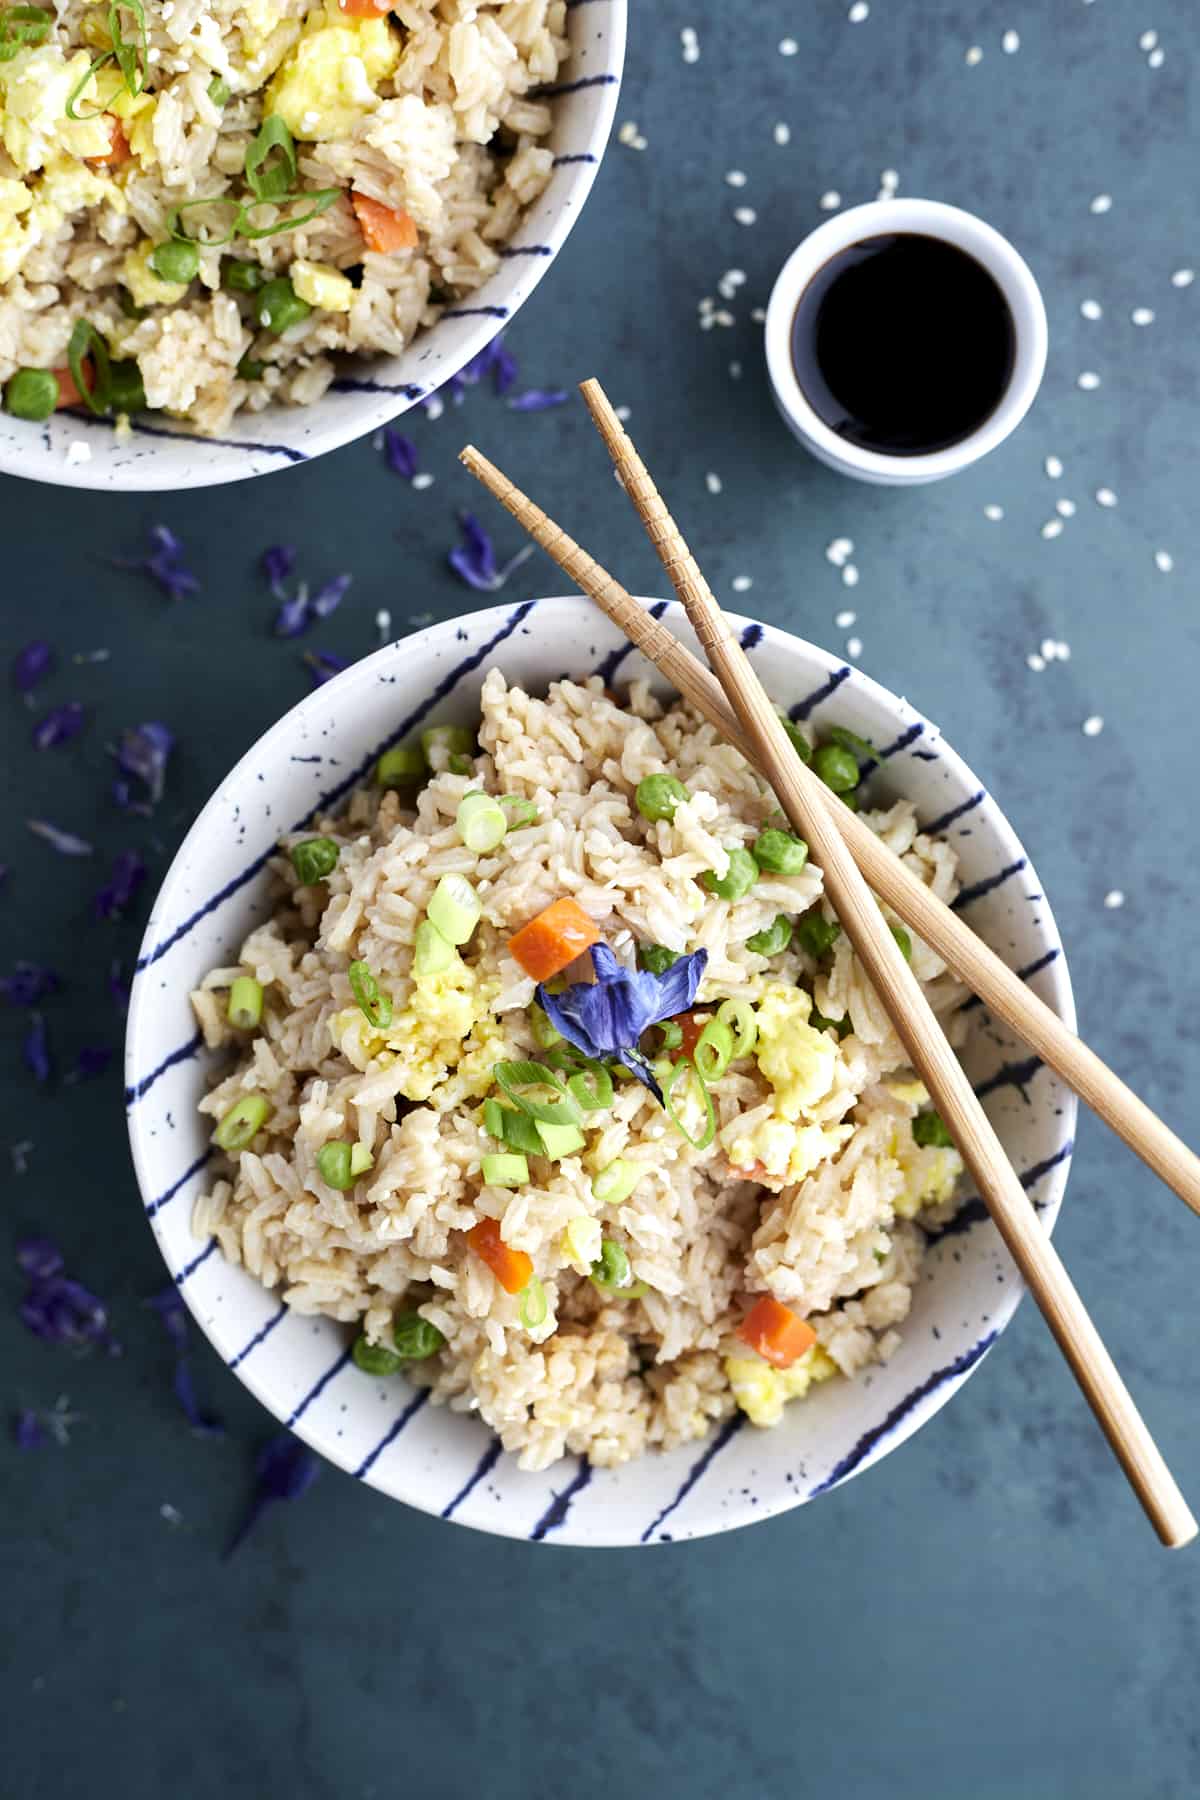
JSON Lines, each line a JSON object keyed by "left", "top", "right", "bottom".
{"left": 461, "top": 445, "right": 1200, "bottom": 1213}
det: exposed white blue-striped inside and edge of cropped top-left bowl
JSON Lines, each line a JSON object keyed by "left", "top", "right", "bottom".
{"left": 0, "top": 0, "right": 628, "bottom": 491}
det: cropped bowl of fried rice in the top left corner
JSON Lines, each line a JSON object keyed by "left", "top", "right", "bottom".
{"left": 0, "top": 0, "right": 626, "bottom": 490}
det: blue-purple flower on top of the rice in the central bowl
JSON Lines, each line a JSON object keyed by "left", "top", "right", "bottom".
{"left": 534, "top": 943, "right": 709, "bottom": 1105}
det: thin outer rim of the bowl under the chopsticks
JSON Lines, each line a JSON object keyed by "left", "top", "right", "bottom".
{"left": 124, "top": 594, "right": 1078, "bottom": 1548}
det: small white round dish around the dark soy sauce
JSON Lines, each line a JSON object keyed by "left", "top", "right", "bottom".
{"left": 765, "top": 200, "right": 1049, "bottom": 488}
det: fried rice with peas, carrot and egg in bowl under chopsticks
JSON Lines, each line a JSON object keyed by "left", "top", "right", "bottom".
{"left": 193, "top": 670, "right": 964, "bottom": 1469}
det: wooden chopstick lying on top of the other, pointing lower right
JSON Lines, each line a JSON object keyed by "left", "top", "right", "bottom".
{"left": 581, "top": 369, "right": 1198, "bottom": 1548}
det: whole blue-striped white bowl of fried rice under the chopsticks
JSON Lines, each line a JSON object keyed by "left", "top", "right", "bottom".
{"left": 126, "top": 599, "right": 1074, "bottom": 1544}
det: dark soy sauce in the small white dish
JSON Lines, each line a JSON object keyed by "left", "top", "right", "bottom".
{"left": 792, "top": 232, "right": 1016, "bottom": 455}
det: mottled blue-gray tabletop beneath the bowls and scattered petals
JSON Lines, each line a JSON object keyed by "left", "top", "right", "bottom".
{"left": 0, "top": 0, "right": 1200, "bottom": 1800}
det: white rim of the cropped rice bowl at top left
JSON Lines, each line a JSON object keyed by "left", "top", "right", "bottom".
{"left": 0, "top": 0, "right": 628, "bottom": 493}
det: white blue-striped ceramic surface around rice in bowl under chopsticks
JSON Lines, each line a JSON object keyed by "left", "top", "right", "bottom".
{"left": 126, "top": 599, "right": 1076, "bottom": 1544}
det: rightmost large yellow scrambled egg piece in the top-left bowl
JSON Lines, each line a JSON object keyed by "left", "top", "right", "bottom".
{"left": 264, "top": 0, "right": 399, "bottom": 144}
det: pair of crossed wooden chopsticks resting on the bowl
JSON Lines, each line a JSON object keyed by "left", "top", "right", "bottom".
{"left": 461, "top": 382, "right": 1200, "bottom": 1548}
